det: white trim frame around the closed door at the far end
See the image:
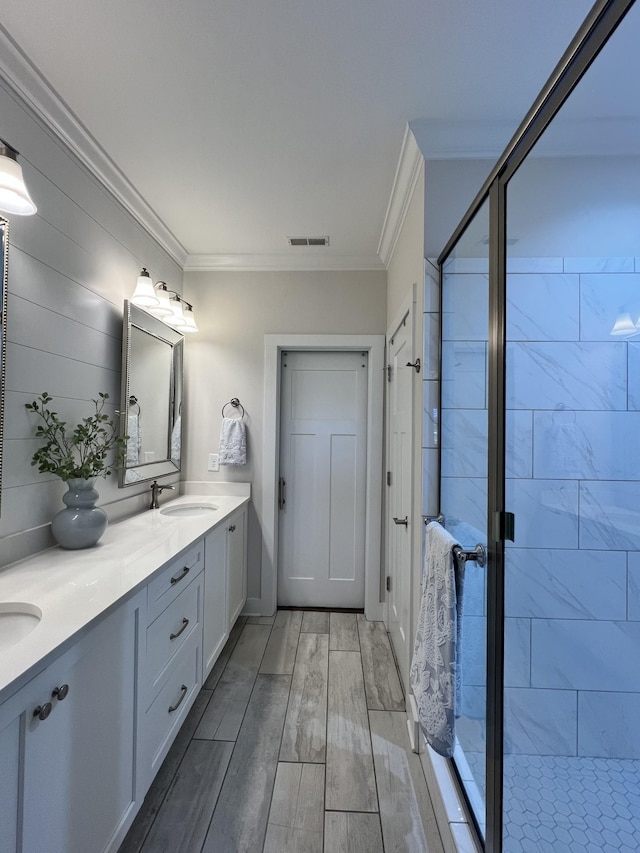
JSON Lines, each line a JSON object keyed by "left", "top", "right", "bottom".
{"left": 260, "top": 334, "right": 385, "bottom": 620}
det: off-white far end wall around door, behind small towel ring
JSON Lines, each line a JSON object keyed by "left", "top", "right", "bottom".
{"left": 184, "top": 271, "right": 386, "bottom": 598}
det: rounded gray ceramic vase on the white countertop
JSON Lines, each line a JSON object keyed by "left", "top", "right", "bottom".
{"left": 51, "top": 477, "right": 107, "bottom": 550}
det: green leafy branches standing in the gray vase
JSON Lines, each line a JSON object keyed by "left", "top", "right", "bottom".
{"left": 25, "top": 391, "right": 127, "bottom": 482}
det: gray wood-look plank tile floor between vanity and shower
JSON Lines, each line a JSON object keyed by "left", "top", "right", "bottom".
{"left": 119, "top": 610, "right": 443, "bottom": 853}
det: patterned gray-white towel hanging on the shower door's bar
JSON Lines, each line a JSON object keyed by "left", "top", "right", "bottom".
{"left": 410, "top": 521, "right": 462, "bottom": 757}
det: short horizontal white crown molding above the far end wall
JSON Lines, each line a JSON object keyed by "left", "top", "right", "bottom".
{"left": 184, "top": 253, "right": 385, "bottom": 272}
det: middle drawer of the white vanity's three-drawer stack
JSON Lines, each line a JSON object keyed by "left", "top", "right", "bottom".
{"left": 145, "top": 574, "right": 203, "bottom": 707}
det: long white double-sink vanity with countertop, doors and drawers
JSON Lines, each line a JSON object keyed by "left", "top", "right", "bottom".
{"left": 0, "top": 497, "right": 246, "bottom": 853}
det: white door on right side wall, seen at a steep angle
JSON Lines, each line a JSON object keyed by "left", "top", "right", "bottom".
{"left": 387, "top": 311, "right": 414, "bottom": 688}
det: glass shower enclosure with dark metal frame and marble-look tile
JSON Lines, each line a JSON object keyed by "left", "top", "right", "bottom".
{"left": 439, "top": 0, "right": 640, "bottom": 853}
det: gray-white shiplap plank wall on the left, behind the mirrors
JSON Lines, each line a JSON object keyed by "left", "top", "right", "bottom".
{"left": 0, "top": 76, "right": 182, "bottom": 565}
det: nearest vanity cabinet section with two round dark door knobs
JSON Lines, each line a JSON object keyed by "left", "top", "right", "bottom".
{"left": 0, "top": 591, "right": 146, "bottom": 853}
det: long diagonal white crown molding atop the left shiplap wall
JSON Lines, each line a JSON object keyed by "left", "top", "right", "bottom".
{"left": 0, "top": 25, "right": 187, "bottom": 266}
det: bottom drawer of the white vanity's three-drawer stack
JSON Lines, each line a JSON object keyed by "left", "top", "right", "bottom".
{"left": 142, "top": 632, "right": 202, "bottom": 782}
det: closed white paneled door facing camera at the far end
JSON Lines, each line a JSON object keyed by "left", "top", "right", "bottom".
{"left": 278, "top": 352, "right": 368, "bottom": 607}
